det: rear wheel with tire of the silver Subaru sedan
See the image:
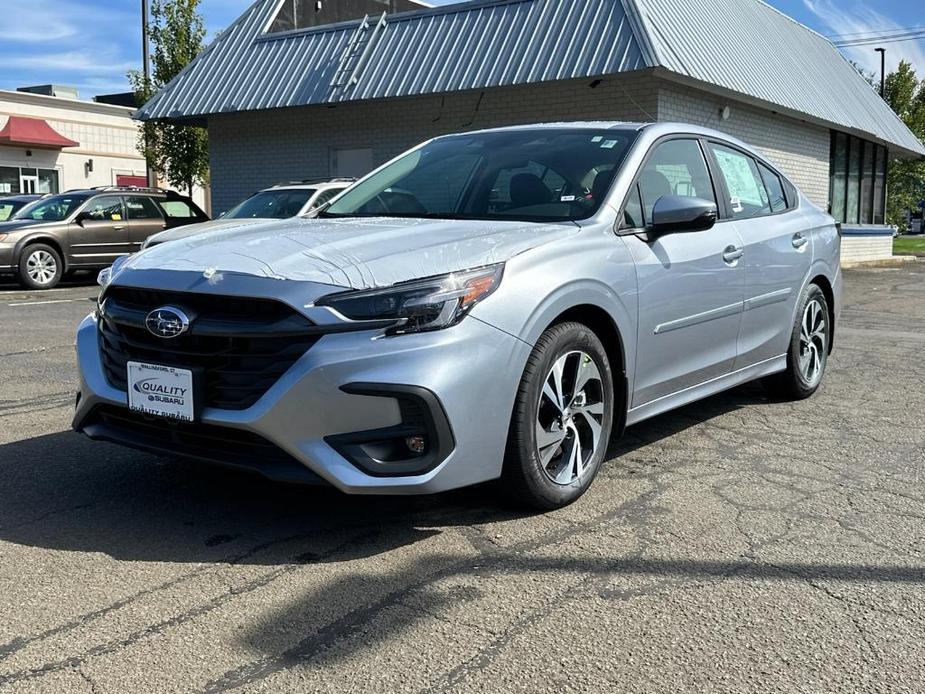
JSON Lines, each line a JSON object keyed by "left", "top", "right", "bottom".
{"left": 762, "top": 284, "right": 832, "bottom": 400}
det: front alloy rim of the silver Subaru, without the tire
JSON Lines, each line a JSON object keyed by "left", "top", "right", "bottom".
{"left": 536, "top": 351, "right": 604, "bottom": 485}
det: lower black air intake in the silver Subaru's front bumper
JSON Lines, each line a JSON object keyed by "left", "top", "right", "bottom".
{"left": 80, "top": 405, "right": 322, "bottom": 484}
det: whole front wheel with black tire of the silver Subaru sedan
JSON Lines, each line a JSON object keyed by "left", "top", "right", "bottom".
{"left": 502, "top": 323, "right": 614, "bottom": 511}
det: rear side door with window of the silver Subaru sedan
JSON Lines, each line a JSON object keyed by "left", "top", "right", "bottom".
{"left": 709, "top": 142, "right": 812, "bottom": 369}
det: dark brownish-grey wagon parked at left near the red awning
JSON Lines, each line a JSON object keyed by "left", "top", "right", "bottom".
{"left": 0, "top": 187, "right": 209, "bottom": 289}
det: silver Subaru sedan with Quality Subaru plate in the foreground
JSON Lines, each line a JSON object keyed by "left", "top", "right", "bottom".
{"left": 74, "top": 123, "right": 841, "bottom": 508}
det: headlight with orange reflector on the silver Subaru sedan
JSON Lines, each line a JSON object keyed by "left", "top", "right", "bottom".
{"left": 317, "top": 265, "right": 504, "bottom": 335}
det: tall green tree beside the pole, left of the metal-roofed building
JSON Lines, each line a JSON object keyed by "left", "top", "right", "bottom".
{"left": 129, "top": 0, "right": 209, "bottom": 193}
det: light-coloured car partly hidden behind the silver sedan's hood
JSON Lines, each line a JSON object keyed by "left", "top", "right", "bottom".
{"left": 142, "top": 178, "right": 356, "bottom": 248}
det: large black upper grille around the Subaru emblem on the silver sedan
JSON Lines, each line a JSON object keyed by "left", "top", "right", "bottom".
{"left": 99, "top": 287, "right": 320, "bottom": 410}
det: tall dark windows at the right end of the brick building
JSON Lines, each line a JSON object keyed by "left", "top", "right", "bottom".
{"left": 829, "top": 131, "right": 889, "bottom": 224}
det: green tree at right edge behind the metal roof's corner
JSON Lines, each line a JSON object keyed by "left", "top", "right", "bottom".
{"left": 884, "top": 61, "right": 925, "bottom": 230}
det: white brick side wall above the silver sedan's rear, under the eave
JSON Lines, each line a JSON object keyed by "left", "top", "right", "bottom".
{"left": 658, "top": 82, "right": 830, "bottom": 209}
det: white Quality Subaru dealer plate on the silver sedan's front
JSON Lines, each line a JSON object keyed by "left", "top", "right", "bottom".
{"left": 128, "top": 361, "right": 195, "bottom": 422}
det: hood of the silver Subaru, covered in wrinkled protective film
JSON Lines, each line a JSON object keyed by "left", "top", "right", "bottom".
{"left": 119, "top": 218, "right": 579, "bottom": 289}
